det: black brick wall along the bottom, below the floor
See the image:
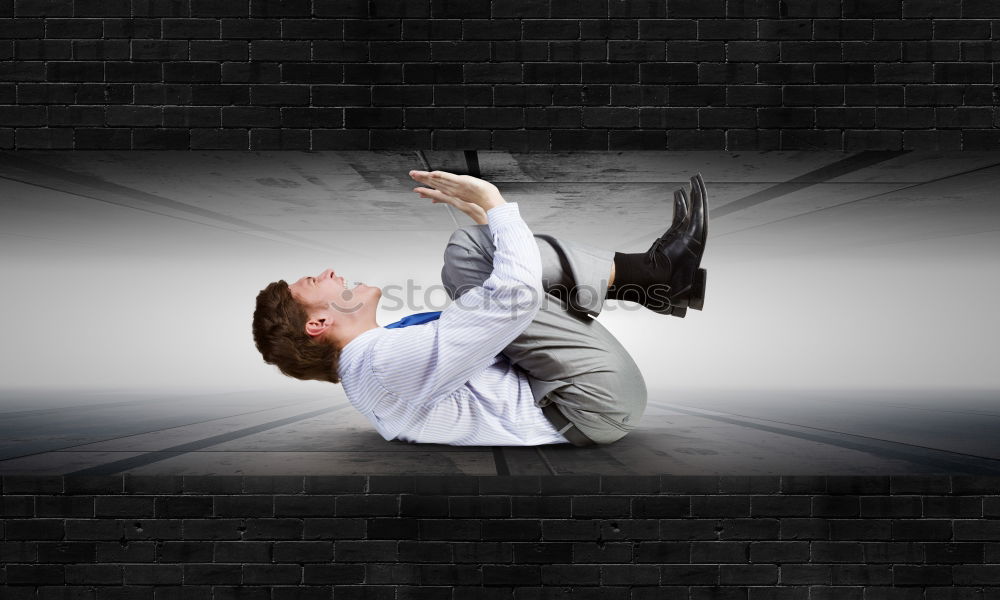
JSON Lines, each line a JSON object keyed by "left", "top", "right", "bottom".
{"left": 0, "top": 476, "right": 1000, "bottom": 600}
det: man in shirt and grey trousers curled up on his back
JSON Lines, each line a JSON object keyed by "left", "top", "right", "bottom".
{"left": 253, "top": 171, "right": 708, "bottom": 446}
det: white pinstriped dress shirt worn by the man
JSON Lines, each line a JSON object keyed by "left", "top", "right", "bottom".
{"left": 339, "top": 202, "right": 567, "bottom": 446}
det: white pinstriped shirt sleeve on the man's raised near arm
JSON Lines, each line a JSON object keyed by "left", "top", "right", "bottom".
{"left": 373, "top": 203, "right": 544, "bottom": 402}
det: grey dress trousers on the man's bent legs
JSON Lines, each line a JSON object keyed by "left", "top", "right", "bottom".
{"left": 441, "top": 225, "right": 646, "bottom": 445}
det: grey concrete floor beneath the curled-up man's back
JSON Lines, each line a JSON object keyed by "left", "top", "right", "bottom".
{"left": 0, "top": 388, "right": 1000, "bottom": 475}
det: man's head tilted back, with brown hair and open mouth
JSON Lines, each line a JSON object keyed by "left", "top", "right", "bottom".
{"left": 253, "top": 269, "right": 382, "bottom": 383}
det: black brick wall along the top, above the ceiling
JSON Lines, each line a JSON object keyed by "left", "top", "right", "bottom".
{"left": 0, "top": 0, "right": 1000, "bottom": 151}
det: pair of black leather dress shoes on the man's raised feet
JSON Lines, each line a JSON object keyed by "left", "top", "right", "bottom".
{"left": 643, "top": 173, "right": 708, "bottom": 317}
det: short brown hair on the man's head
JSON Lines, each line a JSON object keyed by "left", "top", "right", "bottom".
{"left": 253, "top": 280, "right": 340, "bottom": 383}
